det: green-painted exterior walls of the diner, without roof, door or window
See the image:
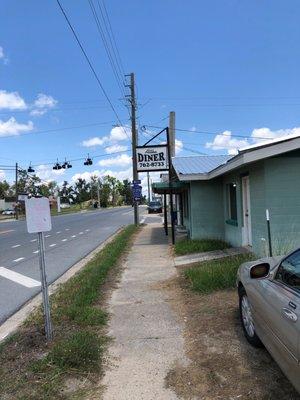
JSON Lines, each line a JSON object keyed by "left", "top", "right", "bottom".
{"left": 180, "top": 152, "right": 300, "bottom": 256}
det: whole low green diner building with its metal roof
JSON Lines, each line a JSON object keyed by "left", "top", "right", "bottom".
{"left": 169, "top": 136, "right": 300, "bottom": 255}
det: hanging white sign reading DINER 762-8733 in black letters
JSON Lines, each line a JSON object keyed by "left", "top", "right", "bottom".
{"left": 136, "top": 144, "right": 169, "bottom": 172}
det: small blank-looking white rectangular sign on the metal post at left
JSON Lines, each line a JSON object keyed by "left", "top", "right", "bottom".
{"left": 25, "top": 197, "right": 52, "bottom": 233}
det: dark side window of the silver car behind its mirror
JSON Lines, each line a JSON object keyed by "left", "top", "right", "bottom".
{"left": 276, "top": 250, "right": 300, "bottom": 290}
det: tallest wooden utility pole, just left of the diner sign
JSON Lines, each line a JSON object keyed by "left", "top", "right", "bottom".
{"left": 126, "top": 73, "right": 139, "bottom": 226}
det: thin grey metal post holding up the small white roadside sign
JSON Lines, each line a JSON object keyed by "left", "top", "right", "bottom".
{"left": 38, "top": 232, "right": 53, "bottom": 341}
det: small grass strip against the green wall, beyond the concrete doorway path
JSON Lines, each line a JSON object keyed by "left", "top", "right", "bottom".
{"left": 174, "top": 239, "right": 230, "bottom": 256}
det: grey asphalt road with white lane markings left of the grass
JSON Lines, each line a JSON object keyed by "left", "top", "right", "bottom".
{"left": 0, "top": 207, "right": 144, "bottom": 324}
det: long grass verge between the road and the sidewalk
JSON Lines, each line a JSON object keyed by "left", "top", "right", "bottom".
{"left": 0, "top": 226, "right": 137, "bottom": 400}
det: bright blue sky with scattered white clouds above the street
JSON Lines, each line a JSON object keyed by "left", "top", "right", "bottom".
{"left": 0, "top": 0, "right": 300, "bottom": 191}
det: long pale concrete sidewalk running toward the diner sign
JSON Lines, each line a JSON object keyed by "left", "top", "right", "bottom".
{"left": 103, "top": 223, "right": 187, "bottom": 400}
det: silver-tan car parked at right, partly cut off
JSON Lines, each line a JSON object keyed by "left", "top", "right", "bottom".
{"left": 237, "top": 249, "right": 300, "bottom": 393}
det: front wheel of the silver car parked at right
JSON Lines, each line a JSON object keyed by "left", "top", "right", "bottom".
{"left": 239, "top": 287, "right": 263, "bottom": 347}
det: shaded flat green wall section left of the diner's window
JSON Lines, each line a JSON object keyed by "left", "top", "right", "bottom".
{"left": 190, "top": 179, "right": 224, "bottom": 239}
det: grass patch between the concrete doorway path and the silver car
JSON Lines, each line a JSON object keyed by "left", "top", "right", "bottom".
{"left": 184, "top": 253, "right": 255, "bottom": 294}
